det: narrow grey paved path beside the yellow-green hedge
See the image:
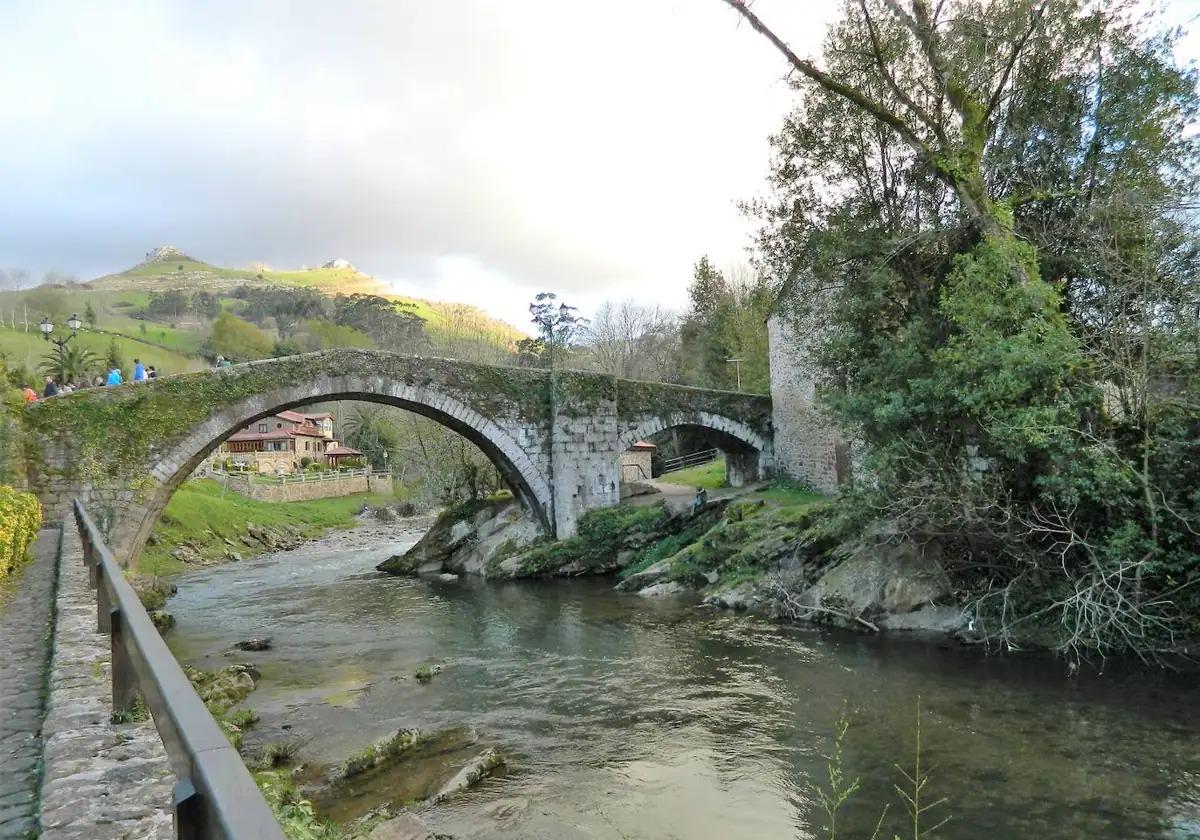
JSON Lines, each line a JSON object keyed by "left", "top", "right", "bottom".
{"left": 0, "top": 528, "right": 59, "bottom": 838}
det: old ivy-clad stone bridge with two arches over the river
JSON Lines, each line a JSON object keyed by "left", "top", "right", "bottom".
{"left": 23, "top": 349, "right": 773, "bottom": 562}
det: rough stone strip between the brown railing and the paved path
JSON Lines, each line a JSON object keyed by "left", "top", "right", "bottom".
{"left": 41, "top": 527, "right": 175, "bottom": 840}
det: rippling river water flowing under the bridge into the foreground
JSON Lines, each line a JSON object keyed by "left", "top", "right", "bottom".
{"left": 169, "top": 528, "right": 1200, "bottom": 840}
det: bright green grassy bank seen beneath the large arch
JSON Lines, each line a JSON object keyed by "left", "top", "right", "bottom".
{"left": 138, "top": 479, "right": 394, "bottom": 577}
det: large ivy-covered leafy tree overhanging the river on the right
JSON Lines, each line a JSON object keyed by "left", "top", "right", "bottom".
{"left": 724, "top": 0, "right": 1200, "bottom": 655}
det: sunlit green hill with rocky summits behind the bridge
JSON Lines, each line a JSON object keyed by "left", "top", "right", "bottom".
{"left": 0, "top": 247, "right": 523, "bottom": 381}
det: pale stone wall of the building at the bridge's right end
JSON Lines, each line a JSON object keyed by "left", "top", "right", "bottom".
{"left": 767, "top": 314, "right": 848, "bottom": 492}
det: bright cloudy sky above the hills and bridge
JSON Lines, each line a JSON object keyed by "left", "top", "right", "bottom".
{"left": 0, "top": 0, "right": 1200, "bottom": 326}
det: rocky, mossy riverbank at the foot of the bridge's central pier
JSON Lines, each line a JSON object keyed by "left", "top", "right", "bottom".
{"left": 378, "top": 485, "right": 967, "bottom": 632}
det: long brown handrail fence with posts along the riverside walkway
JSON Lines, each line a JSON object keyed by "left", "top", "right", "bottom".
{"left": 74, "top": 499, "right": 283, "bottom": 840}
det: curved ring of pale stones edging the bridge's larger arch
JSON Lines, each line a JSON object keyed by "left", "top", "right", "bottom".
{"left": 119, "top": 374, "right": 553, "bottom": 562}
